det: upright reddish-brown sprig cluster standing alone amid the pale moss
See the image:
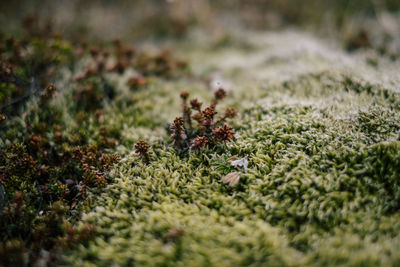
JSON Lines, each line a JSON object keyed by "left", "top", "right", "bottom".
{"left": 168, "top": 88, "right": 237, "bottom": 153}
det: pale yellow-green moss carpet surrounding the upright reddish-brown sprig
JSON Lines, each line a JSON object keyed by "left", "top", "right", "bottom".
{"left": 58, "top": 30, "right": 400, "bottom": 266}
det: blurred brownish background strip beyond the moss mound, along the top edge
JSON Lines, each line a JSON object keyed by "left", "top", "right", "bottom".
{"left": 0, "top": 0, "right": 400, "bottom": 55}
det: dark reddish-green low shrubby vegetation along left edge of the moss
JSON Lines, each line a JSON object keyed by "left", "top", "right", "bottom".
{"left": 0, "top": 16, "right": 191, "bottom": 266}
